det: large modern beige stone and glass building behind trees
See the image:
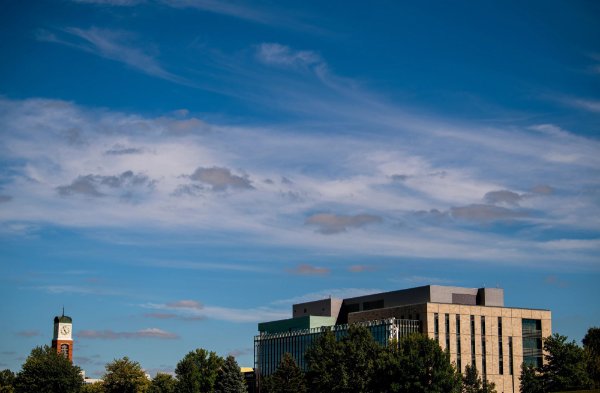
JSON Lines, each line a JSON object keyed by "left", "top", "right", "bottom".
{"left": 254, "top": 285, "right": 552, "bottom": 393}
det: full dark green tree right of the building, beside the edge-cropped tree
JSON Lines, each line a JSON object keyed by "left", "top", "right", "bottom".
{"left": 541, "top": 333, "right": 592, "bottom": 392}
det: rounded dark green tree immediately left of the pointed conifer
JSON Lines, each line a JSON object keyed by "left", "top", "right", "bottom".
{"left": 175, "top": 348, "right": 224, "bottom": 393}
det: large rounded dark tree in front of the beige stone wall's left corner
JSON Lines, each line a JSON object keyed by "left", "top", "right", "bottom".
{"left": 376, "top": 334, "right": 462, "bottom": 393}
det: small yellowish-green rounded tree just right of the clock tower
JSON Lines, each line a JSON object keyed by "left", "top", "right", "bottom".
{"left": 103, "top": 356, "right": 150, "bottom": 393}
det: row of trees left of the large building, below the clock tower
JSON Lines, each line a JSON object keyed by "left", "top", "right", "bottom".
{"left": 0, "top": 345, "right": 247, "bottom": 393}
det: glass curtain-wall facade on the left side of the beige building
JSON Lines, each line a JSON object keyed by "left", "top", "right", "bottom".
{"left": 254, "top": 318, "right": 421, "bottom": 376}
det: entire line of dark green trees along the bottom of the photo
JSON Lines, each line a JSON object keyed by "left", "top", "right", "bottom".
{"left": 0, "top": 326, "right": 600, "bottom": 393}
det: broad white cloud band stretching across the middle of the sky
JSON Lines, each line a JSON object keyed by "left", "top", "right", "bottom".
{"left": 0, "top": 52, "right": 600, "bottom": 271}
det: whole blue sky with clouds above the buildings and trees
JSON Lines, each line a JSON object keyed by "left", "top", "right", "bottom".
{"left": 0, "top": 0, "right": 600, "bottom": 375}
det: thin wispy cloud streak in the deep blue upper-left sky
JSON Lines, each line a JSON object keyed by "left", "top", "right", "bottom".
{"left": 37, "top": 27, "right": 190, "bottom": 85}
